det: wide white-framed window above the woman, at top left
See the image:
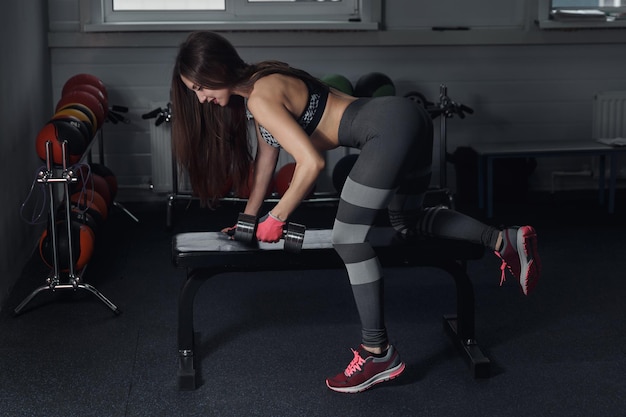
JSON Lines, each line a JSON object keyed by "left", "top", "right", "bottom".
{"left": 83, "top": 0, "right": 381, "bottom": 31}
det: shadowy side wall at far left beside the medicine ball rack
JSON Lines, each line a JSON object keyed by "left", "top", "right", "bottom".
{"left": 0, "top": 0, "right": 51, "bottom": 307}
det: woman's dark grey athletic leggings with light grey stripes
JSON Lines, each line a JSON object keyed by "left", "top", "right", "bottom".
{"left": 332, "top": 97, "right": 499, "bottom": 348}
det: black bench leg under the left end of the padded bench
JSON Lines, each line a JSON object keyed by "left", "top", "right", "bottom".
{"left": 178, "top": 269, "right": 214, "bottom": 391}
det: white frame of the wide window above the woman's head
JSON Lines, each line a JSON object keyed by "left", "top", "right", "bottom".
{"left": 81, "top": 0, "right": 382, "bottom": 32}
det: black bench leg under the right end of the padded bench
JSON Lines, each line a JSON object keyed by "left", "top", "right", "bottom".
{"left": 440, "top": 262, "right": 491, "bottom": 378}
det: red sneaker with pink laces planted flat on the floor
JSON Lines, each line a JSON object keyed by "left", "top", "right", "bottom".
{"left": 326, "top": 345, "right": 405, "bottom": 393}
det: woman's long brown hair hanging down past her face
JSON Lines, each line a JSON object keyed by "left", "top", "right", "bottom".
{"left": 171, "top": 31, "right": 319, "bottom": 205}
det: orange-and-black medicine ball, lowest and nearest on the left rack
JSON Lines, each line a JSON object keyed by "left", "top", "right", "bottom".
{"left": 39, "top": 220, "right": 95, "bottom": 271}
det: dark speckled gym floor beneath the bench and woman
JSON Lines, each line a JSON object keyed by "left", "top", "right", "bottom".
{"left": 0, "top": 193, "right": 626, "bottom": 417}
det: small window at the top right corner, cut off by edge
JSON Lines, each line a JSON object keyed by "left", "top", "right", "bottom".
{"left": 539, "top": 0, "right": 626, "bottom": 29}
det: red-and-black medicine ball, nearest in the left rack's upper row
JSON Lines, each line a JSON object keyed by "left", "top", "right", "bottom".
{"left": 35, "top": 120, "right": 87, "bottom": 165}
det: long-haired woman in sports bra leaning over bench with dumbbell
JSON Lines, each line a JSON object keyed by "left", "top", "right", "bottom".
{"left": 172, "top": 32, "right": 540, "bottom": 392}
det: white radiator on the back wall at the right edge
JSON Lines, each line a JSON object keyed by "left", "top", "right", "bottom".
{"left": 592, "top": 91, "right": 626, "bottom": 139}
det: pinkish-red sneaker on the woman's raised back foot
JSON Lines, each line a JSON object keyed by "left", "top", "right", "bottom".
{"left": 495, "top": 226, "right": 541, "bottom": 295}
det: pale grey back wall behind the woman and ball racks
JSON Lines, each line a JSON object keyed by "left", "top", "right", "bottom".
{"left": 49, "top": 0, "right": 626, "bottom": 195}
